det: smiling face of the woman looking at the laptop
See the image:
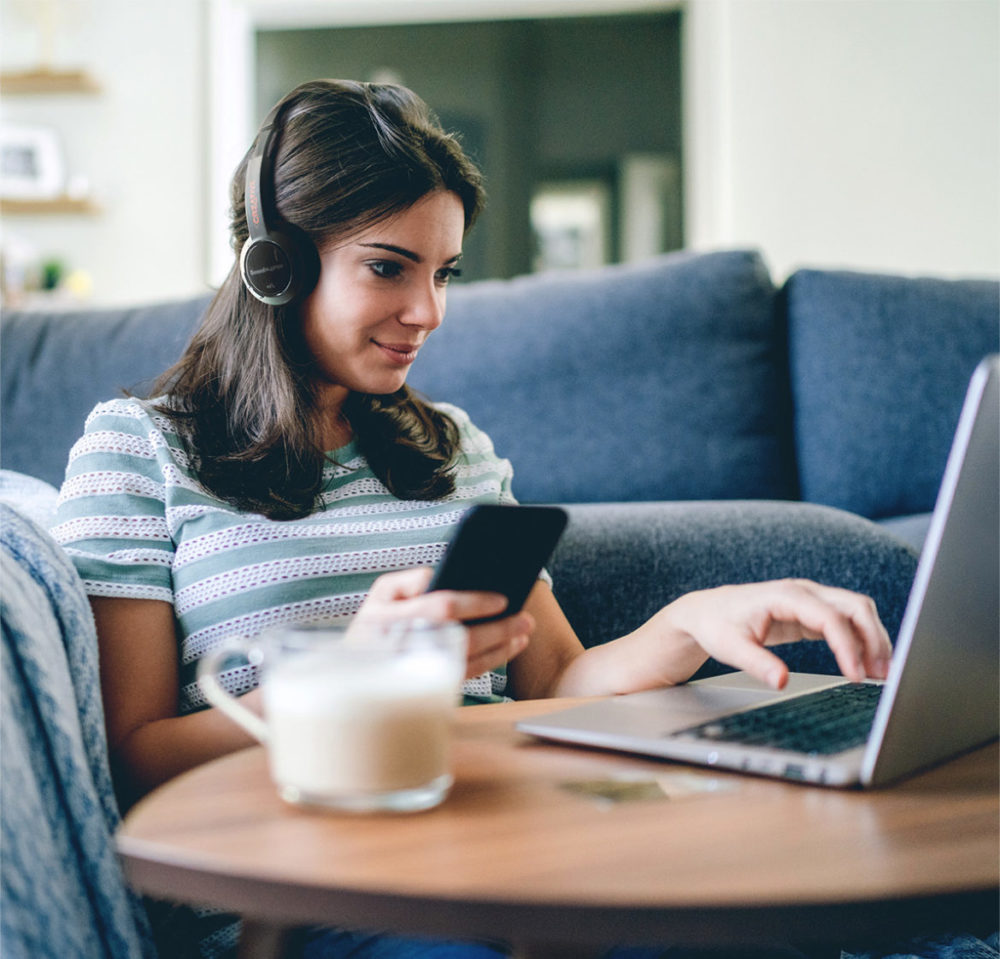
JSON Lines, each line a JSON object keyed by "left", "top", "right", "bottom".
{"left": 302, "top": 190, "right": 465, "bottom": 412}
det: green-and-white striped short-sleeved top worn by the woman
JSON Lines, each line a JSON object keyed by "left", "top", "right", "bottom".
{"left": 53, "top": 399, "right": 514, "bottom": 715}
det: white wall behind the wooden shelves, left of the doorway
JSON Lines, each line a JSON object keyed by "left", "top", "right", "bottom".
{"left": 0, "top": 0, "right": 207, "bottom": 303}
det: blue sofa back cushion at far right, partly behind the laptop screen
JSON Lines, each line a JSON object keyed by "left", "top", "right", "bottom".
{"left": 785, "top": 270, "right": 1000, "bottom": 518}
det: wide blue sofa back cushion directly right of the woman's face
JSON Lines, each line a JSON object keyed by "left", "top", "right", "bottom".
{"left": 410, "top": 251, "right": 792, "bottom": 502}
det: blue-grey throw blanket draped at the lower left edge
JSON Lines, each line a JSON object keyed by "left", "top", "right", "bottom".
{"left": 0, "top": 503, "right": 156, "bottom": 959}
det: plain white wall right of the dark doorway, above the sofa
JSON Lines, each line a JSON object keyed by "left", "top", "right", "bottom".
{"left": 686, "top": 0, "right": 1000, "bottom": 277}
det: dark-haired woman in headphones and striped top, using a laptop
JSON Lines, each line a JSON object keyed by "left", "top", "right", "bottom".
{"left": 56, "top": 81, "right": 890, "bottom": 955}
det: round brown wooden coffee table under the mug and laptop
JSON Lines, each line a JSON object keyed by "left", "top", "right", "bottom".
{"left": 118, "top": 700, "right": 1000, "bottom": 956}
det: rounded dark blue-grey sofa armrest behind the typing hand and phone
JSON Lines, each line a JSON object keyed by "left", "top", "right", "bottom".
{"left": 549, "top": 500, "right": 918, "bottom": 674}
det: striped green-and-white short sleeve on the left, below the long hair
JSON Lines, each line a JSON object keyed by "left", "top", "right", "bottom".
{"left": 52, "top": 400, "right": 174, "bottom": 603}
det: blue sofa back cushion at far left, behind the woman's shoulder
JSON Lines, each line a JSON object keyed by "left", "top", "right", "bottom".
{"left": 0, "top": 297, "right": 209, "bottom": 486}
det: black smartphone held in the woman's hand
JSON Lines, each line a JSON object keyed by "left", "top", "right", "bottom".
{"left": 428, "top": 505, "right": 569, "bottom": 625}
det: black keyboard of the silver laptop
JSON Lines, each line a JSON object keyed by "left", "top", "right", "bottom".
{"left": 675, "top": 683, "right": 882, "bottom": 756}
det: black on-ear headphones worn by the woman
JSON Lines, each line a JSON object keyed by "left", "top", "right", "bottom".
{"left": 240, "top": 102, "right": 318, "bottom": 306}
